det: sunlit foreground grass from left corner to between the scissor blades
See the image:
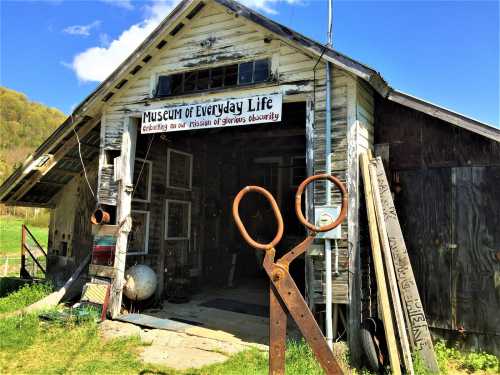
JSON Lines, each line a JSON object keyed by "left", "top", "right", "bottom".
{"left": 0, "top": 315, "right": 322, "bottom": 375}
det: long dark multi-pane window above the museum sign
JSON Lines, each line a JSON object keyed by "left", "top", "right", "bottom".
{"left": 154, "top": 59, "right": 270, "bottom": 98}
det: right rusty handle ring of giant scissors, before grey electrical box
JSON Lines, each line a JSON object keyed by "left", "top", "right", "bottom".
{"left": 295, "top": 174, "right": 347, "bottom": 232}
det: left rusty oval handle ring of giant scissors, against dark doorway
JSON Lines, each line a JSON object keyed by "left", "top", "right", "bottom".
{"left": 233, "top": 186, "right": 284, "bottom": 250}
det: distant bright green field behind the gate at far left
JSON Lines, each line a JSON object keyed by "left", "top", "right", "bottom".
{"left": 0, "top": 216, "right": 48, "bottom": 256}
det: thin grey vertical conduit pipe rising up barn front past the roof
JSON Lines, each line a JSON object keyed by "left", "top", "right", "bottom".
{"left": 325, "top": 0, "right": 333, "bottom": 349}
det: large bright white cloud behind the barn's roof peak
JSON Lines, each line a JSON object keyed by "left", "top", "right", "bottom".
{"left": 71, "top": 0, "right": 300, "bottom": 82}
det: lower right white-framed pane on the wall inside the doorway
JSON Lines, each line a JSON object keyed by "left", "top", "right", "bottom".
{"left": 165, "top": 199, "right": 191, "bottom": 240}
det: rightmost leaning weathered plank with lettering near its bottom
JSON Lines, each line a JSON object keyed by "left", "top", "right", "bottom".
{"left": 375, "top": 158, "right": 439, "bottom": 372}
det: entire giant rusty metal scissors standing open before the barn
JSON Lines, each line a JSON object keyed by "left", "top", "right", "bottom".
{"left": 233, "top": 174, "right": 347, "bottom": 375}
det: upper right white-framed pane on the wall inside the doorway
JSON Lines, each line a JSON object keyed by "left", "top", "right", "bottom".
{"left": 167, "top": 149, "right": 193, "bottom": 190}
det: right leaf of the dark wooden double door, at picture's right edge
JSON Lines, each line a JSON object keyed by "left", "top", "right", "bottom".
{"left": 451, "top": 167, "right": 500, "bottom": 335}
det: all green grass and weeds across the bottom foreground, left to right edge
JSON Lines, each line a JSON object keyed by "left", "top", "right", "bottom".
{"left": 0, "top": 284, "right": 500, "bottom": 375}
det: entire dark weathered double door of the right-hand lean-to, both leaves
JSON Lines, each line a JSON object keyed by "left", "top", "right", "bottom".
{"left": 396, "top": 167, "right": 500, "bottom": 334}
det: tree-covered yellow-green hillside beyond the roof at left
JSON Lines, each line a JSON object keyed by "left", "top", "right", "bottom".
{"left": 0, "top": 86, "right": 66, "bottom": 183}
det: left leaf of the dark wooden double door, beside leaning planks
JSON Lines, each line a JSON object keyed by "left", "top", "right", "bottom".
{"left": 395, "top": 168, "right": 452, "bottom": 328}
